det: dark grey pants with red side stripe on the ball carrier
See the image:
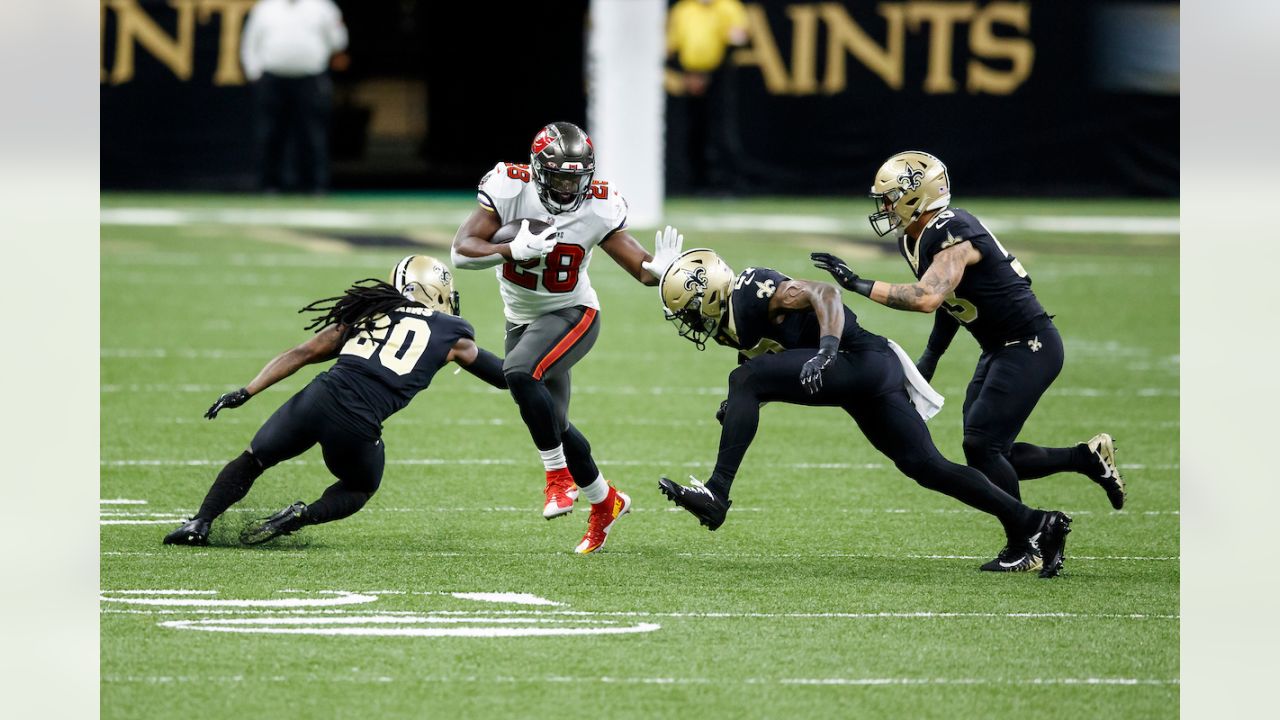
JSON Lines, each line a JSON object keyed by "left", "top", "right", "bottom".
{"left": 502, "top": 305, "right": 600, "bottom": 486}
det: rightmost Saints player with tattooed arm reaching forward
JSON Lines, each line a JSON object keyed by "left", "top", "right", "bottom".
{"left": 812, "top": 151, "right": 1125, "bottom": 571}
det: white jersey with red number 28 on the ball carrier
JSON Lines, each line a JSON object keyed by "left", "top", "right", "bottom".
{"left": 479, "top": 163, "right": 627, "bottom": 325}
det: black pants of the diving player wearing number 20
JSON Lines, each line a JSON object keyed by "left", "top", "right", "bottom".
{"left": 196, "top": 383, "right": 385, "bottom": 525}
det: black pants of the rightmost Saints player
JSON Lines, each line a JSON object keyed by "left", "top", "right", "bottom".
{"left": 964, "top": 324, "right": 1091, "bottom": 498}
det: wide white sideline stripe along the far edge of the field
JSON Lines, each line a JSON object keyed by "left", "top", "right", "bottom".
{"left": 99, "top": 206, "right": 1181, "bottom": 234}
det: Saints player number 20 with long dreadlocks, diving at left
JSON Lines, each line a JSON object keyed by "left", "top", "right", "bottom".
{"left": 164, "top": 255, "right": 507, "bottom": 544}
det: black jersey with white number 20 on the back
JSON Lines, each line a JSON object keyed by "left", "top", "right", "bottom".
{"left": 316, "top": 302, "right": 475, "bottom": 433}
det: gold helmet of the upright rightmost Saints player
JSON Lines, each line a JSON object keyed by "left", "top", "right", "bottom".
{"left": 867, "top": 150, "right": 951, "bottom": 236}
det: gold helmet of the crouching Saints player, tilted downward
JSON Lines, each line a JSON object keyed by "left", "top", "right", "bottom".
{"left": 658, "top": 247, "right": 733, "bottom": 350}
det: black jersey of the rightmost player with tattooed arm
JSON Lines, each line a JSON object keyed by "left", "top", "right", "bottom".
{"left": 899, "top": 208, "right": 1048, "bottom": 350}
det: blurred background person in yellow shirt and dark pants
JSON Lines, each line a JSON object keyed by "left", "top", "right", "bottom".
{"left": 667, "top": 0, "right": 748, "bottom": 191}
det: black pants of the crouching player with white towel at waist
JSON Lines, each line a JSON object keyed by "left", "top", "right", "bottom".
{"left": 707, "top": 345, "right": 1038, "bottom": 538}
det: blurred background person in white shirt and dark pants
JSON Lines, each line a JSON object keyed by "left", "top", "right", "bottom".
{"left": 241, "top": 0, "right": 347, "bottom": 193}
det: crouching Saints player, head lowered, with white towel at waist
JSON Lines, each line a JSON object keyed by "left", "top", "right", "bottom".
{"left": 659, "top": 250, "right": 1071, "bottom": 578}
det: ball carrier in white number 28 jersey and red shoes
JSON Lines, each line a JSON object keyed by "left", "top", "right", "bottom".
{"left": 452, "top": 123, "right": 684, "bottom": 553}
